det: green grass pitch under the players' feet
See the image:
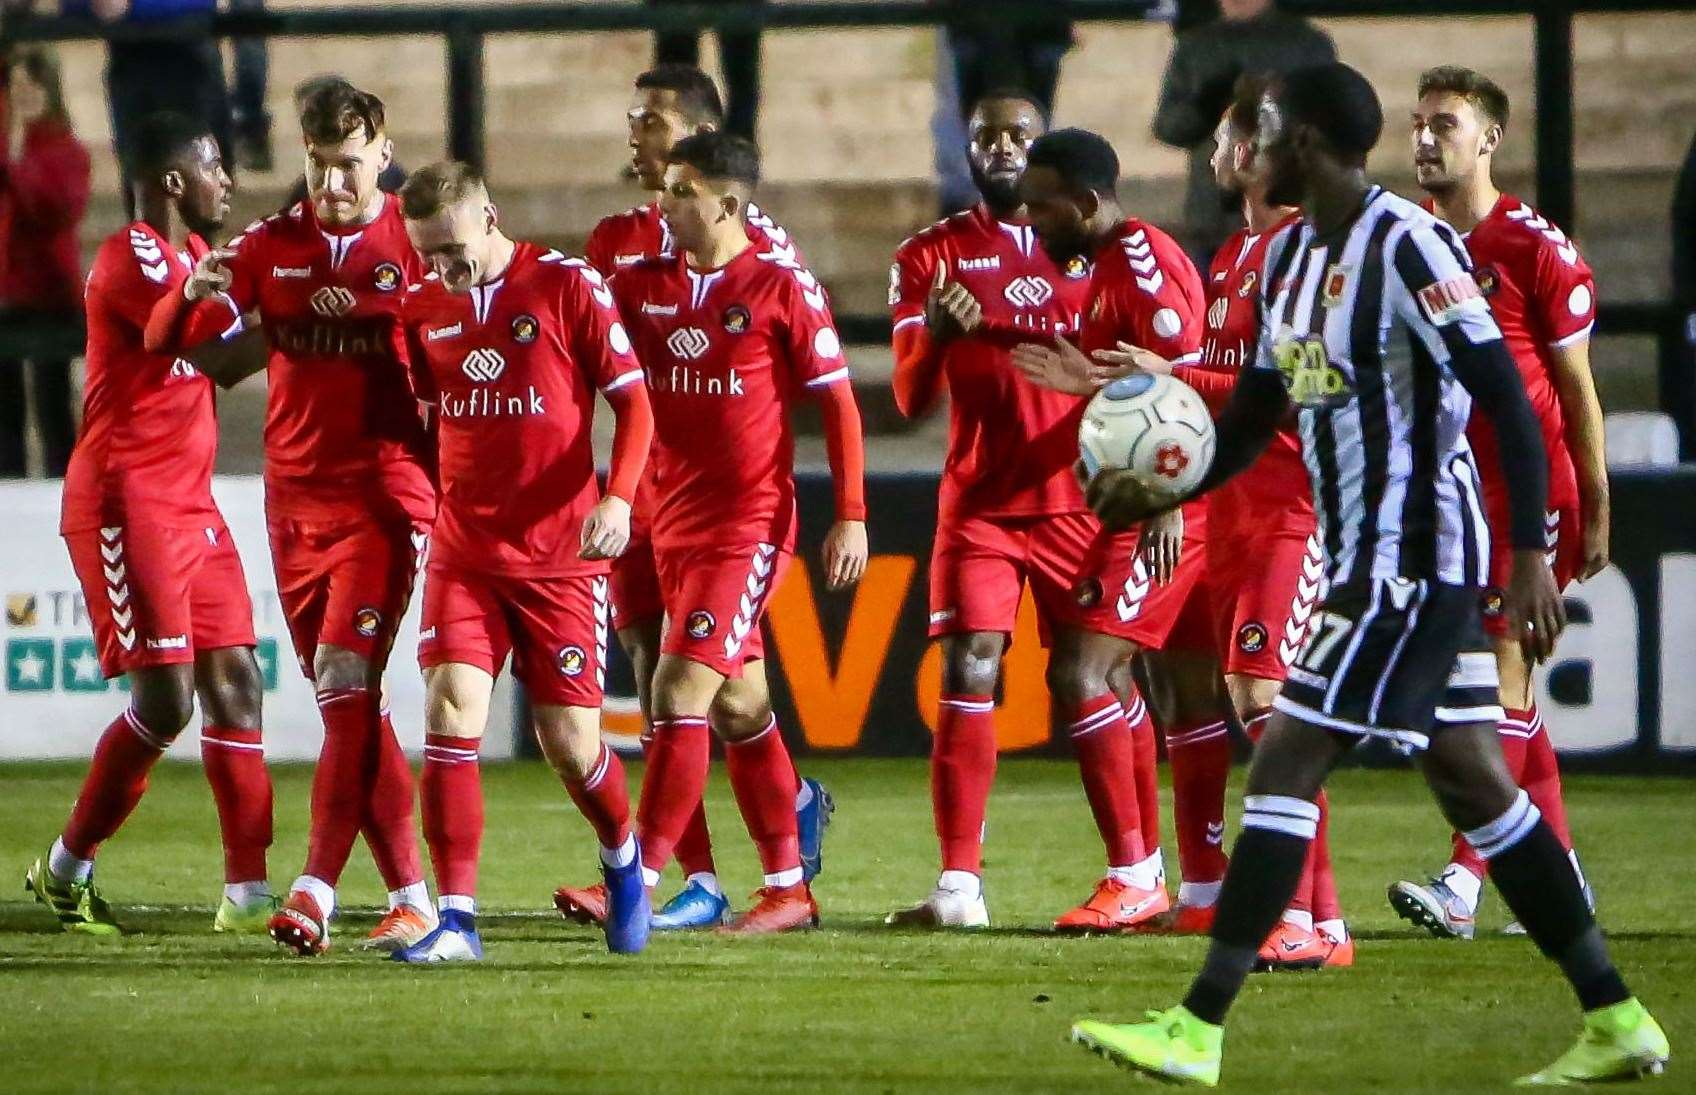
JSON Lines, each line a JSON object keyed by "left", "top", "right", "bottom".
{"left": 0, "top": 759, "right": 1696, "bottom": 1093}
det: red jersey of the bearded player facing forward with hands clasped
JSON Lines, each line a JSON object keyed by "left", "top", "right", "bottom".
{"left": 889, "top": 205, "right": 1089, "bottom": 519}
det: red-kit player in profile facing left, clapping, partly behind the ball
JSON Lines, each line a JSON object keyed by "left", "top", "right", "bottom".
{"left": 1013, "top": 129, "right": 1209, "bottom": 931}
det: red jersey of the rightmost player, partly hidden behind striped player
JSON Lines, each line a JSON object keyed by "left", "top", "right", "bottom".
{"left": 1462, "top": 193, "right": 1596, "bottom": 510}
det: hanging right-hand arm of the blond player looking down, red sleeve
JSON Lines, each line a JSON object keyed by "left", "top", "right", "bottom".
{"left": 560, "top": 266, "right": 653, "bottom": 559}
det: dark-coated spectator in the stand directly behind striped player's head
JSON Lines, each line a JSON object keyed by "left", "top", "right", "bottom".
{"left": 1155, "top": 0, "right": 1336, "bottom": 270}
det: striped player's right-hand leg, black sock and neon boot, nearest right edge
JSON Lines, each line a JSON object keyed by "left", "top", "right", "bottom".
{"left": 1421, "top": 722, "right": 1669, "bottom": 1083}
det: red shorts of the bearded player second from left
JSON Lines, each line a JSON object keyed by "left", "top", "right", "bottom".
{"left": 266, "top": 515, "right": 429, "bottom": 680}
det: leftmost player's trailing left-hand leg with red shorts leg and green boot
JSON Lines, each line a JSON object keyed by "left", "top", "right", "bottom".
{"left": 25, "top": 525, "right": 207, "bottom": 934}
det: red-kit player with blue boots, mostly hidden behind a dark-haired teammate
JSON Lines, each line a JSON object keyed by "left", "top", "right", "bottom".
{"left": 555, "top": 64, "right": 833, "bottom": 931}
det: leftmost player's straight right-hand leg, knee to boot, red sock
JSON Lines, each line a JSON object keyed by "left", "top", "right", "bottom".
{"left": 195, "top": 647, "right": 278, "bottom": 934}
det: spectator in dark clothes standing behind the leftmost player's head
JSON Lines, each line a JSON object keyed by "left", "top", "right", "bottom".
{"left": 61, "top": 0, "right": 236, "bottom": 217}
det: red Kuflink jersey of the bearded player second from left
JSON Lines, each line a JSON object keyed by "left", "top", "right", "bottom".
{"left": 227, "top": 198, "right": 436, "bottom": 520}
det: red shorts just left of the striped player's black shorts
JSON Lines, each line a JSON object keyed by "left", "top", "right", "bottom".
{"left": 1208, "top": 529, "right": 1325, "bottom": 681}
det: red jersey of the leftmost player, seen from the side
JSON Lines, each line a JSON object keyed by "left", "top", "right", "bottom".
{"left": 59, "top": 220, "right": 220, "bottom": 532}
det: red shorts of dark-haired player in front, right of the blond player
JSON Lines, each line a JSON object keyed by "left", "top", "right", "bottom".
{"left": 655, "top": 544, "right": 790, "bottom": 676}
